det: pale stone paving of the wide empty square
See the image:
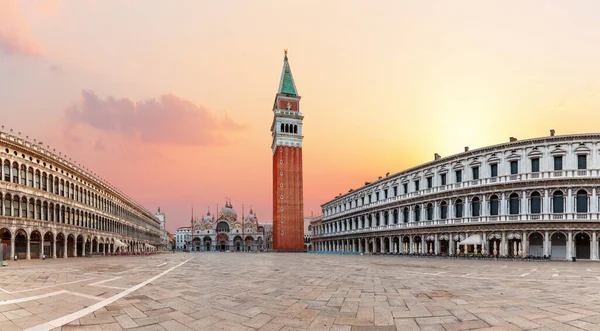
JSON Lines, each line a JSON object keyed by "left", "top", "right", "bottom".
{"left": 0, "top": 253, "right": 600, "bottom": 330}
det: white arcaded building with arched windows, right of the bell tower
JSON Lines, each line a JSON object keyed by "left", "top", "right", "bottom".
{"left": 311, "top": 130, "right": 600, "bottom": 260}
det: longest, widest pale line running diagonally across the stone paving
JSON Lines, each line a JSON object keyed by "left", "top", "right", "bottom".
{"left": 22, "top": 257, "right": 193, "bottom": 331}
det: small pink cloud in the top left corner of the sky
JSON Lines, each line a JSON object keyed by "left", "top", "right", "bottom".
{"left": 0, "top": 0, "right": 42, "bottom": 56}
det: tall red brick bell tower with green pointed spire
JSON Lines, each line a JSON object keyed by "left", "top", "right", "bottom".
{"left": 271, "top": 50, "right": 304, "bottom": 251}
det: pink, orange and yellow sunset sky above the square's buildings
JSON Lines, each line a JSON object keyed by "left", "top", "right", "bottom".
{"left": 0, "top": 0, "right": 600, "bottom": 232}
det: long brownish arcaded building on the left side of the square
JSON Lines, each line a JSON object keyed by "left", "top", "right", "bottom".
{"left": 0, "top": 132, "right": 160, "bottom": 259}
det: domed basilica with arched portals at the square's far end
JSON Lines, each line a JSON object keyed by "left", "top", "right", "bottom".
{"left": 176, "top": 201, "right": 264, "bottom": 252}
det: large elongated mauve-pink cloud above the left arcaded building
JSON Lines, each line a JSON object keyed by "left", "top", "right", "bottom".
{"left": 64, "top": 90, "right": 244, "bottom": 146}
